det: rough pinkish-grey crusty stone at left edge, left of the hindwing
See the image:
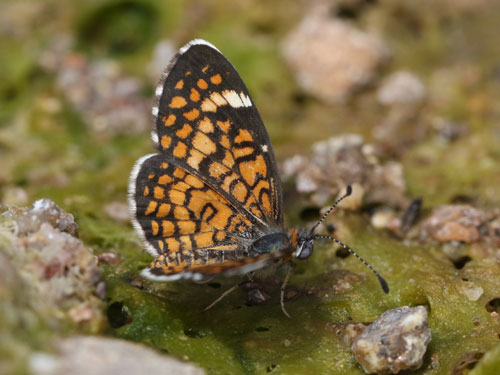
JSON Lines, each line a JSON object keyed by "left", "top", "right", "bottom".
{"left": 0, "top": 199, "right": 104, "bottom": 331}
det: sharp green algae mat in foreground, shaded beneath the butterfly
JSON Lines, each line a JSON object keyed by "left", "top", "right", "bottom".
{"left": 107, "top": 214, "right": 500, "bottom": 374}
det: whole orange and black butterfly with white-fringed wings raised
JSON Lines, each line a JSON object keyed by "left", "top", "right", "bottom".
{"left": 129, "top": 39, "right": 388, "bottom": 314}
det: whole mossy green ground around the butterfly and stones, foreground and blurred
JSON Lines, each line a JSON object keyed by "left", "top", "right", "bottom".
{"left": 0, "top": 0, "right": 500, "bottom": 375}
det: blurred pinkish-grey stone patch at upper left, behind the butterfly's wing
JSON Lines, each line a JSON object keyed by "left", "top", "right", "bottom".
{"left": 40, "top": 37, "right": 151, "bottom": 136}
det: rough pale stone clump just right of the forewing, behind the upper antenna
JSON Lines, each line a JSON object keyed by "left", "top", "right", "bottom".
{"left": 282, "top": 134, "right": 410, "bottom": 210}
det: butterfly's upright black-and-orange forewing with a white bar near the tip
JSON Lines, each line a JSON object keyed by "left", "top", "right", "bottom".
{"left": 153, "top": 42, "right": 283, "bottom": 226}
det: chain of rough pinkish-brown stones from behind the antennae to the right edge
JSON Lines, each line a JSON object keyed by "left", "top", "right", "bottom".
{"left": 282, "top": 134, "right": 500, "bottom": 261}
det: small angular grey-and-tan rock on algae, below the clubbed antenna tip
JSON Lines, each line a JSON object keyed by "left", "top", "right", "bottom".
{"left": 351, "top": 306, "right": 431, "bottom": 374}
